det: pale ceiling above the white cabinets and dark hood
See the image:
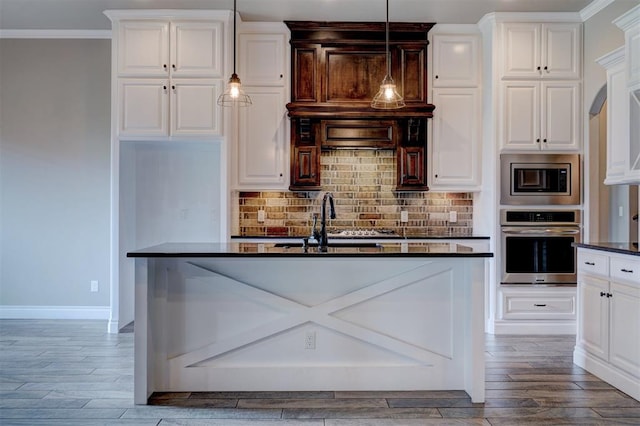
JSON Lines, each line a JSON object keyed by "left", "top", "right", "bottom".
{"left": 0, "top": 0, "right": 597, "bottom": 30}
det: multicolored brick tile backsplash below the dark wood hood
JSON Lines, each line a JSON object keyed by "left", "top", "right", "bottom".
{"left": 235, "top": 150, "right": 473, "bottom": 236}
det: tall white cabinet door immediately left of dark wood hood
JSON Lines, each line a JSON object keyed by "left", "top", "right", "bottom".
{"left": 237, "top": 87, "right": 288, "bottom": 189}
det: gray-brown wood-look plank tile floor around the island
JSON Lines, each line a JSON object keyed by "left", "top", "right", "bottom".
{"left": 0, "top": 320, "right": 640, "bottom": 426}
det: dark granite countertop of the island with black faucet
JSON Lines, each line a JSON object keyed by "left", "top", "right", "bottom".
{"left": 127, "top": 242, "right": 493, "bottom": 258}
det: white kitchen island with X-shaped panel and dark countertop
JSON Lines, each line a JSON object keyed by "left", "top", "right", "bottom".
{"left": 127, "top": 241, "right": 492, "bottom": 404}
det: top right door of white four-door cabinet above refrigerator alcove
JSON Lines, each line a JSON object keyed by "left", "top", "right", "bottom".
{"left": 170, "top": 21, "right": 224, "bottom": 78}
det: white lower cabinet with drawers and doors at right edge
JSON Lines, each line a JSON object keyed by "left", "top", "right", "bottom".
{"left": 574, "top": 248, "right": 640, "bottom": 399}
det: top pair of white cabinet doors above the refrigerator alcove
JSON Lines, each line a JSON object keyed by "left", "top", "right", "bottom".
{"left": 117, "top": 20, "right": 224, "bottom": 78}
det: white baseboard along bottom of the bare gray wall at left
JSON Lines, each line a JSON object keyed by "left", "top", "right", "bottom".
{"left": 0, "top": 305, "right": 110, "bottom": 320}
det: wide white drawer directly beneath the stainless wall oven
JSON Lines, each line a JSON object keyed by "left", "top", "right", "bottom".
{"left": 503, "top": 292, "right": 576, "bottom": 320}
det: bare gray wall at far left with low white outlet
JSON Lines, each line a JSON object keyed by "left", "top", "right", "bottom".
{"left": 0, "top": 39, "right": 111, "bottom": 310}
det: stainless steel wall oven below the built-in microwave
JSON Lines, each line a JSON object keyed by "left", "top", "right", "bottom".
{"left": 500, "top": 210, "right": 581, "bottom": 285}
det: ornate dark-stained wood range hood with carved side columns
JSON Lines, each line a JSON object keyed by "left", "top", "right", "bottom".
{"left": 285, "top": 21, "right": 435, "bottom": 191}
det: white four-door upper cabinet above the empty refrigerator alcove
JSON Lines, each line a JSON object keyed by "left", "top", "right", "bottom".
{"left": 105, "top": 10, "right": 229, "bottom": 140}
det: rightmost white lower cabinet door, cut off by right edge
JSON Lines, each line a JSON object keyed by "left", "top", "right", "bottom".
{"left": 609, "top": 282, "right": 640, "bottom": 378}
